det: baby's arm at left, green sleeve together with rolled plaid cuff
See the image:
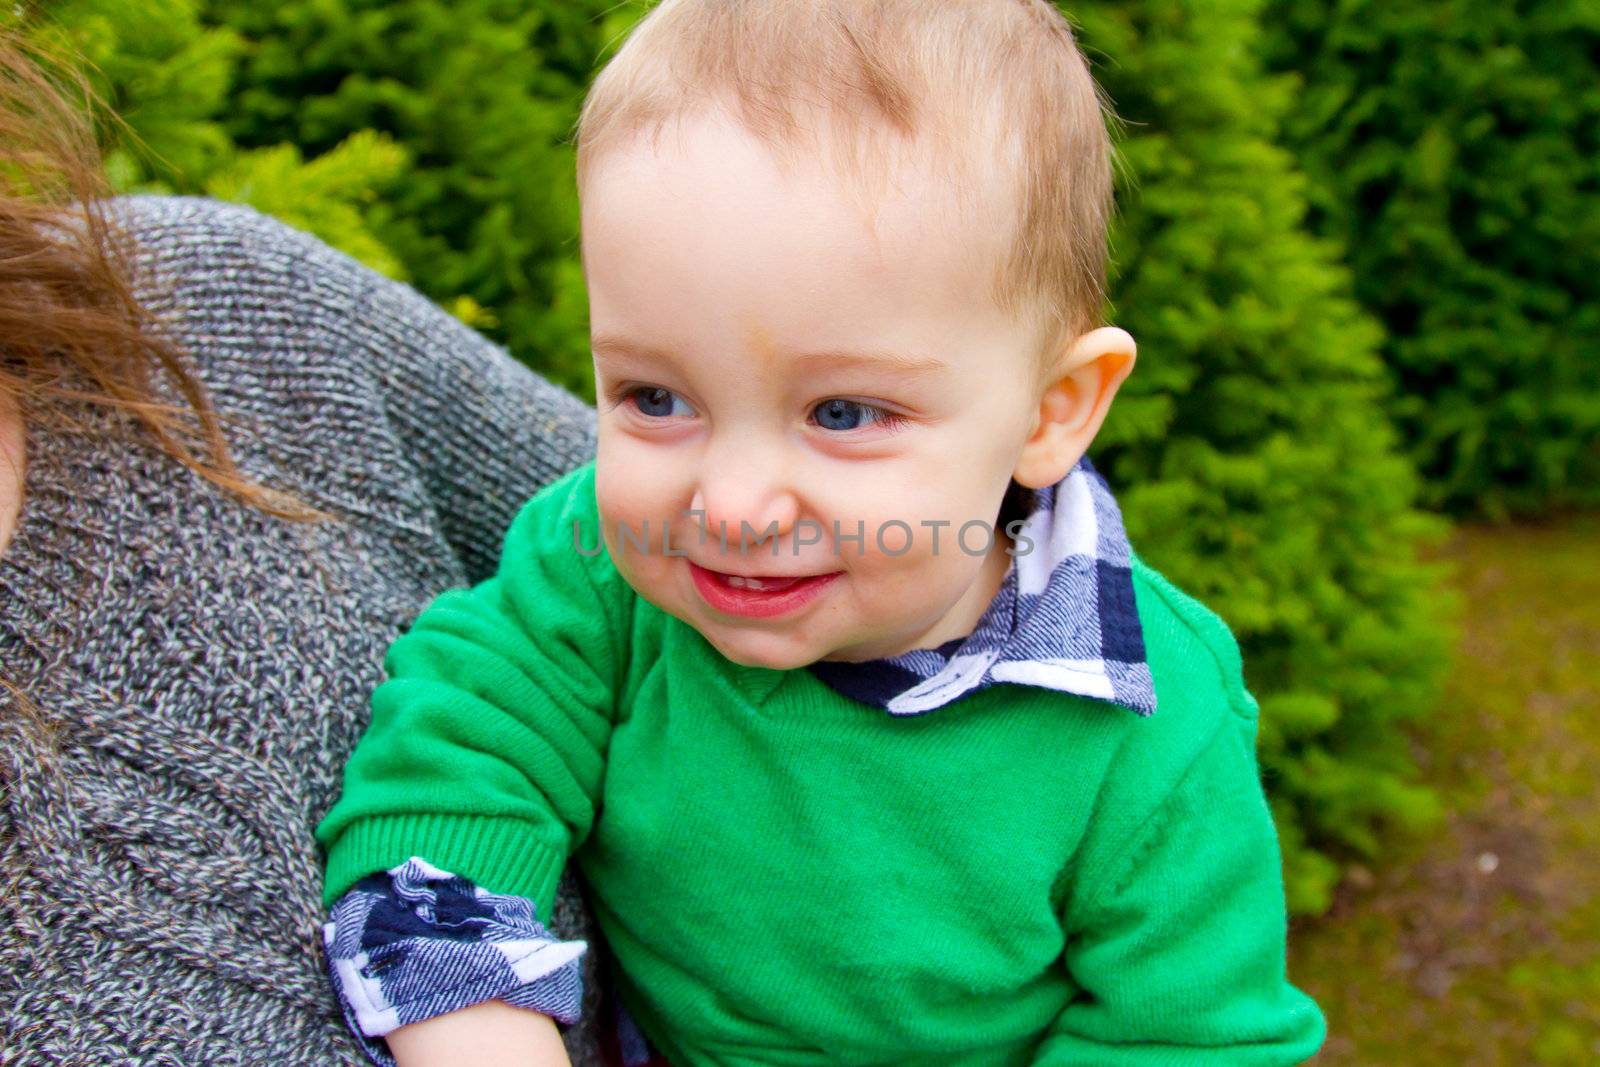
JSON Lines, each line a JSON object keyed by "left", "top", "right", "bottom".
{"left": 317, "top": 464, "right": 617, "bottom": 1064}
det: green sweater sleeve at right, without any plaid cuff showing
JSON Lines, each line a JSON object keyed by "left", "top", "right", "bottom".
{"left": 1034, "top": 703, "right": 1326, "bottom": 1067}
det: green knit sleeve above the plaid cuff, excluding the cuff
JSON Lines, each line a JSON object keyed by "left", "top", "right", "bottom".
{"left": 317, "top": 466, "right": 632, "bottom": 918}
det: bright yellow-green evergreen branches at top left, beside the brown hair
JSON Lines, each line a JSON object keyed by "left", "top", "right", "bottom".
{"left": 19, "top": 0, "right": 405, "bottom": 277}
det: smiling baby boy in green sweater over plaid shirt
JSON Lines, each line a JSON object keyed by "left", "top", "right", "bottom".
{"left": 318, "top": 0, "right": 1323, "bottom": 1067}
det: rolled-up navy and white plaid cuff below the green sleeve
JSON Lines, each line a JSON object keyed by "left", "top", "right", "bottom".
{"left": 323, "top": 856, "right": 589, "bottom": 1067}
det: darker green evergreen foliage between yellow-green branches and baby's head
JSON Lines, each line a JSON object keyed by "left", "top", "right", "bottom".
{"left": 203, "top": 0, "right": 626, "bottom": 397}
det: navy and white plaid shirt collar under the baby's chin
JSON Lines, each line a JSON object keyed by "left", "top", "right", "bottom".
{"left": 808, "top": 456, "right": 1155, "bottom": 715}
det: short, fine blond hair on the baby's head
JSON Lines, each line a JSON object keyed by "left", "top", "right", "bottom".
{"left": 578, "top": 0, "right": 1114, "bottom": 361}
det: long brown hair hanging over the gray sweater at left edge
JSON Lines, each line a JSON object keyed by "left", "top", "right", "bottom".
{"left": 0, "top": 30, "right": 305, "bottom": 518}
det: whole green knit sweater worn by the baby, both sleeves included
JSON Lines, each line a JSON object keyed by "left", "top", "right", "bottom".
{"left": 318, "top": 464, "right": 1325, "bottom": 1067}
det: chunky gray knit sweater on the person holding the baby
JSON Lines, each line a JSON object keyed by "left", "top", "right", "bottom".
{"left": 0, "top": 198, "right": 600, "bottom": 1065}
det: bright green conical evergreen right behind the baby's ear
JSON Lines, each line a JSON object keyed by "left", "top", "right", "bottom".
{"left": 1070, "top": 0, "right": 1448, "bottom": 912}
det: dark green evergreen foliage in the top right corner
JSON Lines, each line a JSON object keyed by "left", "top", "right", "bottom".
{"left": 1266, "top": 0, "right": 1600, "bottom": 515}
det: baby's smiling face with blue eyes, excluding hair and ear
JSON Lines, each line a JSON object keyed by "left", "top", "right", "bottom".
{"left": 582, "top": 117, "right": 1040, "bottom": 669}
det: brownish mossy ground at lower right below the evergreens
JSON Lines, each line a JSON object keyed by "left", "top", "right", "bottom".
{"left": 1290, "top": 514, "right": 1600, "bottom": 1067}
